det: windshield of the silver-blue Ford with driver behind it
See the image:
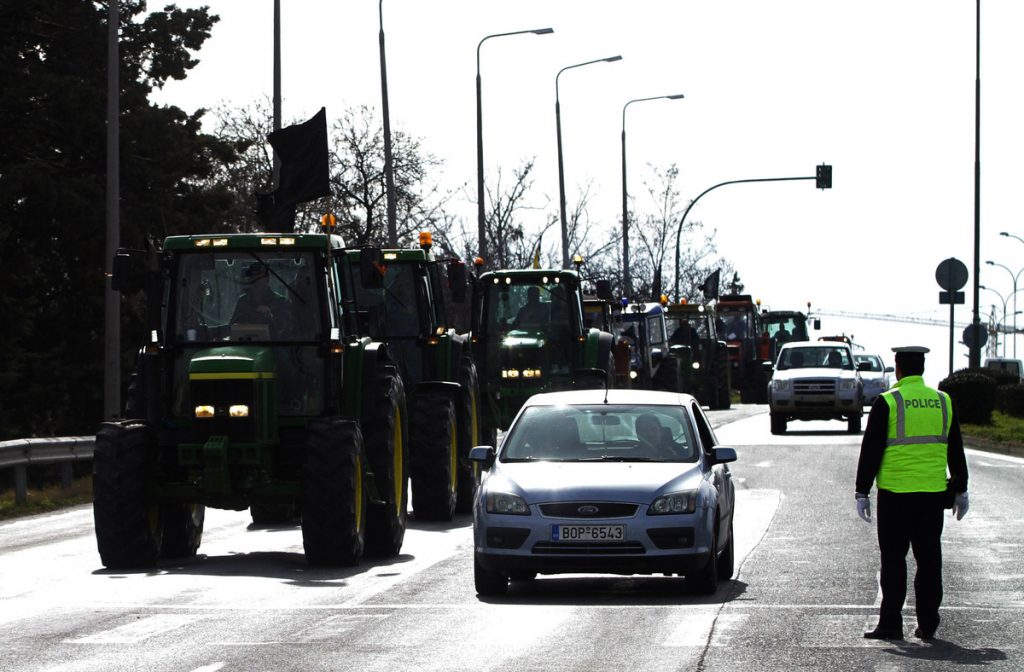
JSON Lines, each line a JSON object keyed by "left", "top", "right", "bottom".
{"left": 501, "top": 404, "right": 697, "bottom": 462}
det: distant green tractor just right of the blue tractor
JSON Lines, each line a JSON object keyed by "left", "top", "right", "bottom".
{"left": 665, "top": 303, "right": 732, "bottom": 410}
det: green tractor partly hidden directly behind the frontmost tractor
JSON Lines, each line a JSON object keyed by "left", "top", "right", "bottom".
{"left": 348, "top": 232, "right": 480, "bottom": 520}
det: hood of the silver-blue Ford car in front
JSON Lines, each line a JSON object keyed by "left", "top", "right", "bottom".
{"left": 486, "top": 462, "right": 701, "bottom": 504}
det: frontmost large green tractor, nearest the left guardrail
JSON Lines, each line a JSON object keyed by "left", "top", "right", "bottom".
{"left": 93, "top": 234, "right": 409, "bottom": 569}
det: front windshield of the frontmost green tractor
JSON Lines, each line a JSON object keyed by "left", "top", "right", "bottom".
{"left": 168, "top": 250, "right": 323, "bottom": 342}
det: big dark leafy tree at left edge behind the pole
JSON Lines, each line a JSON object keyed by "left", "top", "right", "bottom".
{"left": 0, "top": 0, "right": 234, "bottom": 437}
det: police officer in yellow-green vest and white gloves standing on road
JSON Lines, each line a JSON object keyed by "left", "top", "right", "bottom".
{"left": 856, "top": 345, "right": 968, "bottom": 639}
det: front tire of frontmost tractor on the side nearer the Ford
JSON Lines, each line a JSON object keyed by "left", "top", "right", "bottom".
{"left": 302, "top": 417, "right": 367, "bottom": 566}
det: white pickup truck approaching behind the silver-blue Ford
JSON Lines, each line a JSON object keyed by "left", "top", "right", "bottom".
{"left": 768, "top": 341, "right": 868, "bottom": 434}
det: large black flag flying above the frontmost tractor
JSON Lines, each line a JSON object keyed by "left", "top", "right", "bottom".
{"left": 267, "top": 108, "right": 331, "bottom": 207}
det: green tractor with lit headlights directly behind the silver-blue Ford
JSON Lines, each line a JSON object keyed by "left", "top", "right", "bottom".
{"left": 471, "top": 268, "right": 614, "bottom": 438}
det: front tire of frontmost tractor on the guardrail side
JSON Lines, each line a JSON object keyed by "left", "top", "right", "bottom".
{"left": 92, "top": 422, "right": 163, "bottom": 570}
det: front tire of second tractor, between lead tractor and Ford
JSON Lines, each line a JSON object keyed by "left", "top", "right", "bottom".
{"left": 410, "top": 390, "right": 459, "bottom": 520}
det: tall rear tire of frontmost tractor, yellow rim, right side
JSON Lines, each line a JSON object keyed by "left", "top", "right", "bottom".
{"left": 362, "top": 367, "right": 410, "bottom": 556}
